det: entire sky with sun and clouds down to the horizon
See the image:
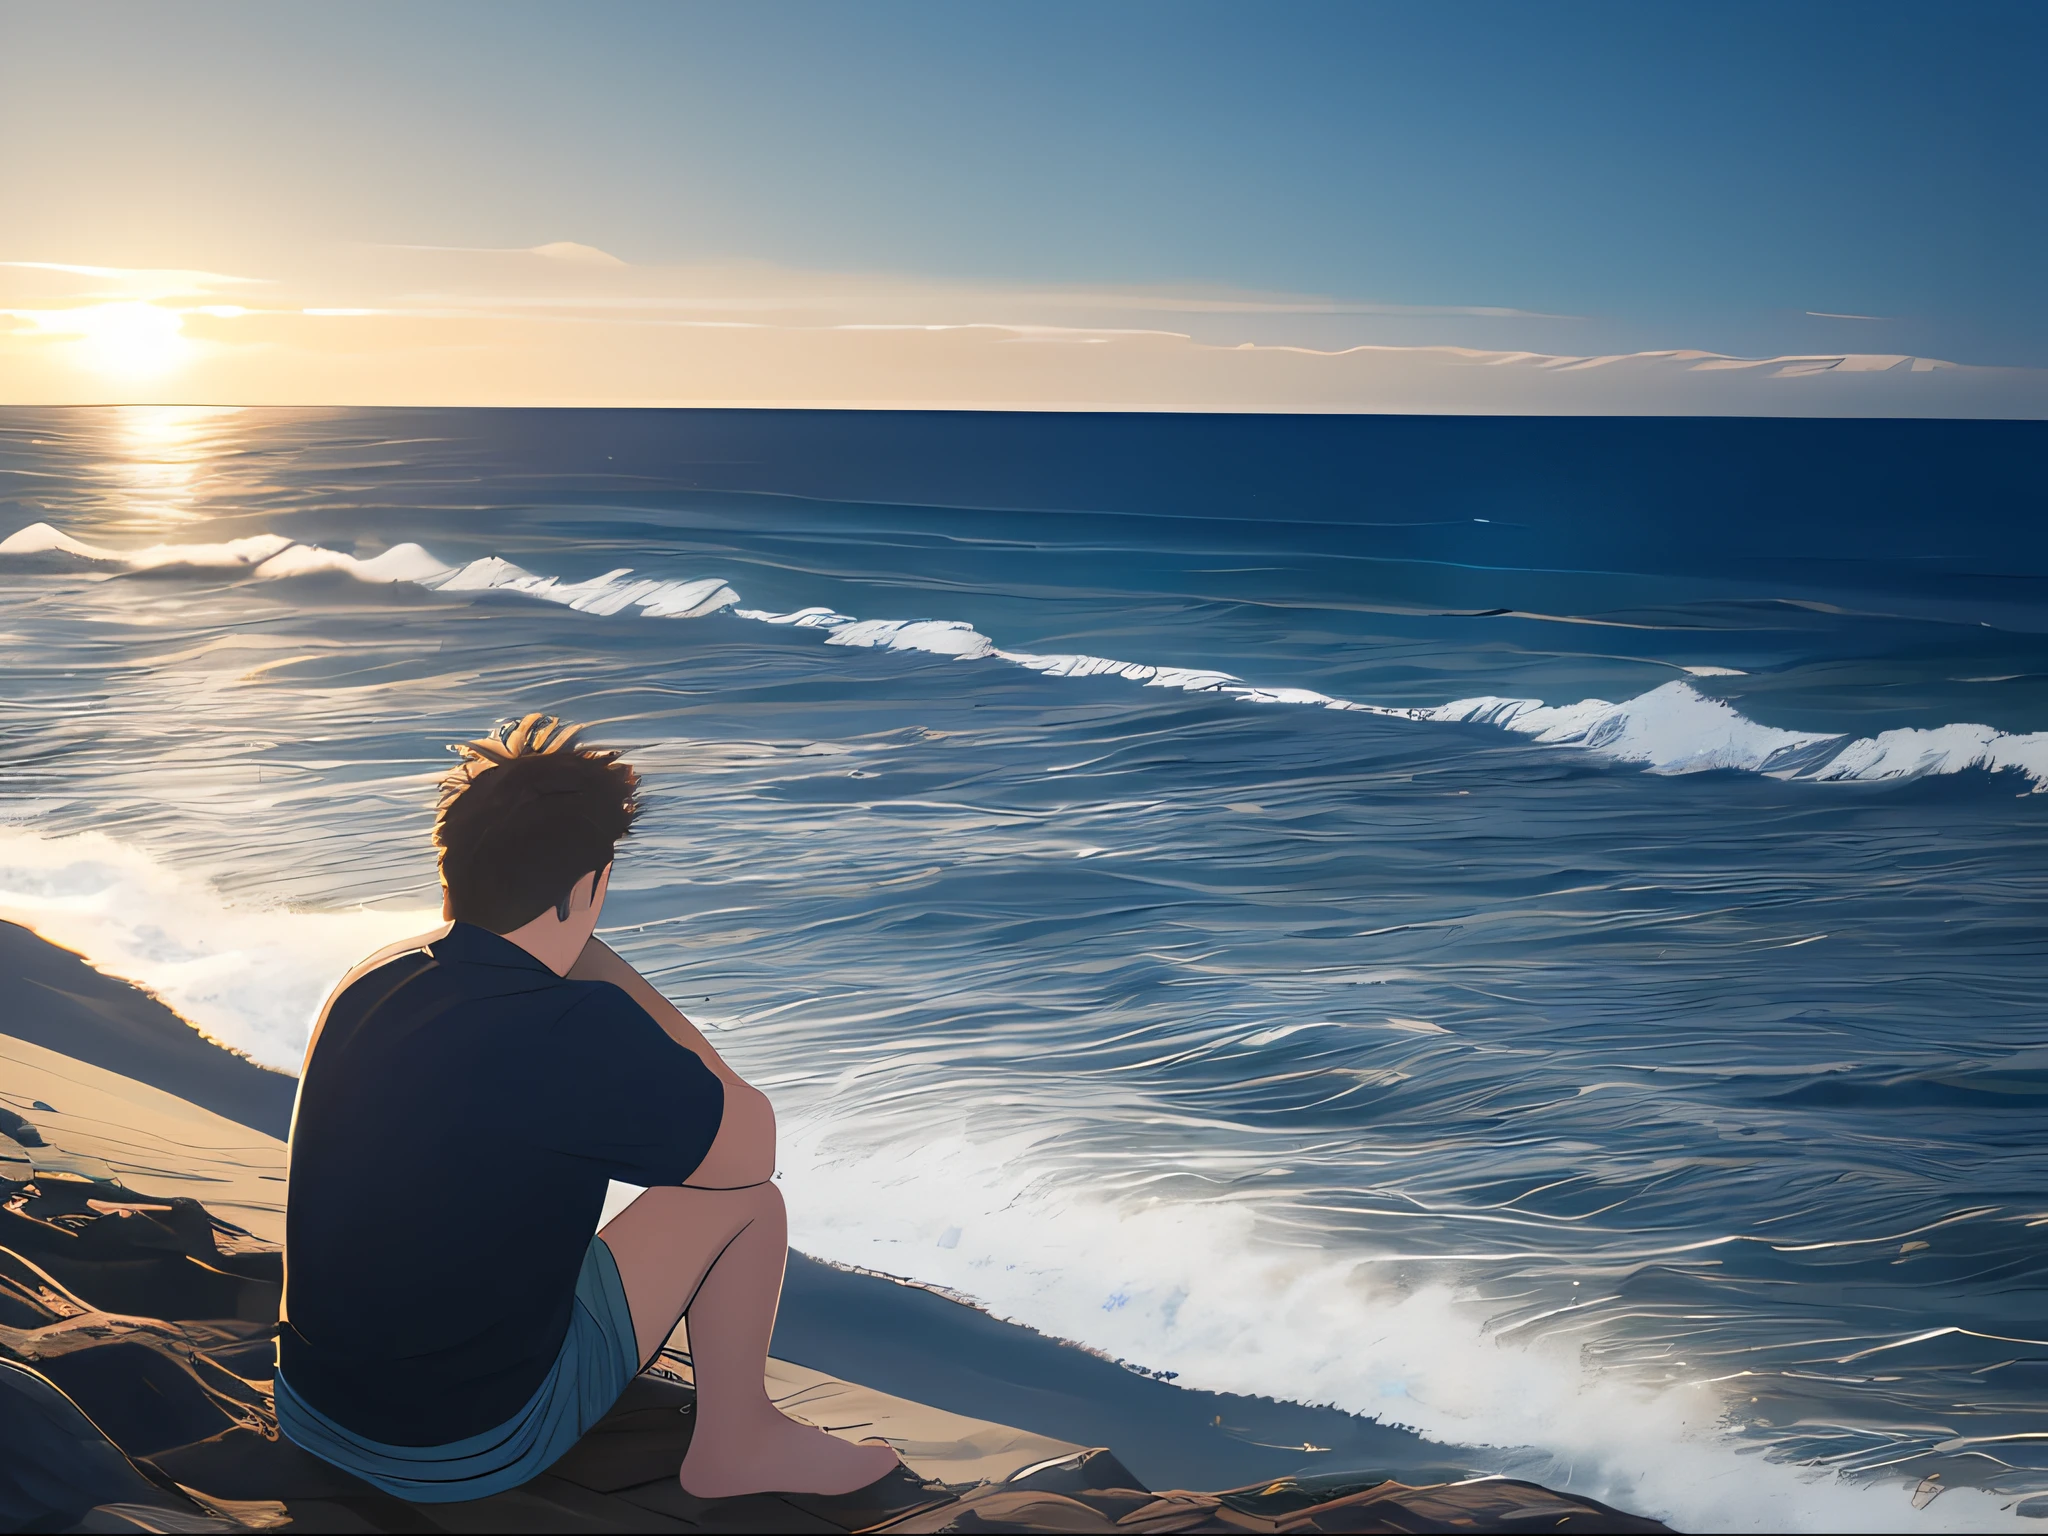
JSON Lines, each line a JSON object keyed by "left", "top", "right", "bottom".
{"left": 0, "top": 0, "right": 2048, "bottom": 414}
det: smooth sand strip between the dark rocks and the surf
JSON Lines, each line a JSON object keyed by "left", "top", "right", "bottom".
{"left": 0, "top": 924, "right": 1640, "bottom": 1528}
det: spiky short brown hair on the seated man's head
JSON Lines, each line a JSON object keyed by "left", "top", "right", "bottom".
{"left": 434, "top": 715, "right": 639, "bottom": 934}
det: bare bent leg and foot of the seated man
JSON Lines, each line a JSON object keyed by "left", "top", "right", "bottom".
{"left": 604, "top": 1184, "right": 897, "bottom": 1499}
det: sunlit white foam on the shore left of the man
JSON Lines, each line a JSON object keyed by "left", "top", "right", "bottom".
{"left": 0, "top": 827, "right": 440, "bottom": 1071}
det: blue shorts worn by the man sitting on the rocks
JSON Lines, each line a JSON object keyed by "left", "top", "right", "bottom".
{"left": 276, "top": 1237, "right": 639, "bottom": 1503}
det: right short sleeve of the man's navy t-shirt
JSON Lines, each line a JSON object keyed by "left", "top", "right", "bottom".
{"left": 535, "top": 981, "right": 725, "bottom": 1184}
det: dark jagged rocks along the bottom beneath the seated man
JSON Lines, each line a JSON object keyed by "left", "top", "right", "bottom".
{"left": 0, "top": 1182, "right": 1665, "bottom": 1536}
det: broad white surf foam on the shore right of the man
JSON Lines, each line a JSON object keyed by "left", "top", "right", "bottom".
{"left": 780, "top": 1112, "right": 2028, "bottom": 1532}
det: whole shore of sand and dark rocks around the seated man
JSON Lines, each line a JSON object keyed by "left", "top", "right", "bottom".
{"left": 0, "top": 924, "right": 1661, "bottom": 1532}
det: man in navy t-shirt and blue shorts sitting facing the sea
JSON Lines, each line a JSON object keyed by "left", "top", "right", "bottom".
{"left": 276, "top": 715, "right": 897, "bottom": 1501}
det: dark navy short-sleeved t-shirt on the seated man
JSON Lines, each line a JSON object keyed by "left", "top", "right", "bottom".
{"left": 279, "top": 924, "right": 725, "bottom": 1446}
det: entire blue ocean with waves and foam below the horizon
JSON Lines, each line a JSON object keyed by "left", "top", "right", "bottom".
{"left": 0, "top": 410, "right": 2048, "bottom": 1530}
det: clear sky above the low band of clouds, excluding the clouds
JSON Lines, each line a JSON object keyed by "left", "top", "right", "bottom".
{"left": 0, "top": 0, "right": 2048, "bottom": 403}
